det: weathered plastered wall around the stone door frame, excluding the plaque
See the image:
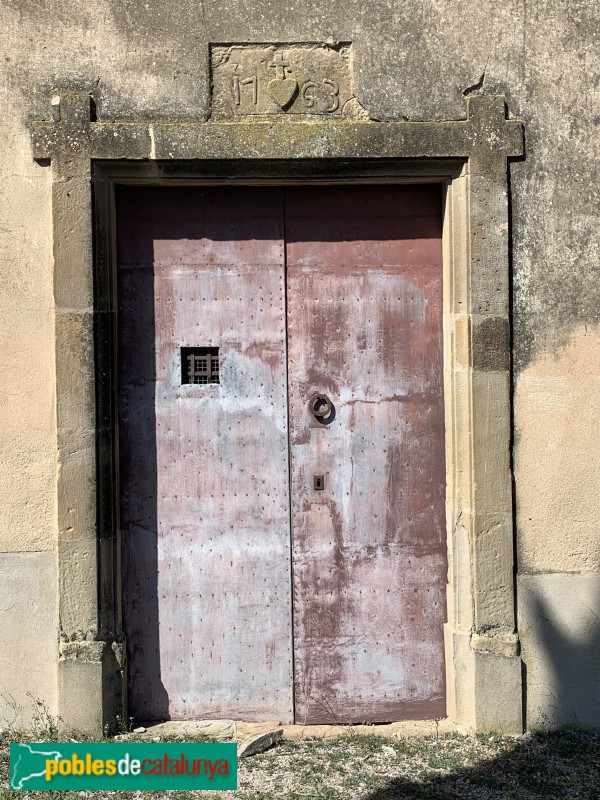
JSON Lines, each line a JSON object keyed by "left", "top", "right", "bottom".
{"left": 0, "top": 0, "right": 600, "bottom": 727}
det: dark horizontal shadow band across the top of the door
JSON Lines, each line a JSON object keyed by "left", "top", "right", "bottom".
{"left": 118, "top": 184, "right": 441, "bottom": 255}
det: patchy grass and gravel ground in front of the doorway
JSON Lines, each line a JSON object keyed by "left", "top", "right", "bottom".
{"left": 0, "top": 729, "right": 600, "bottom": 800}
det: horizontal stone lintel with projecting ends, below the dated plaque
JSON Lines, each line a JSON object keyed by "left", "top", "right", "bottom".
{"left": 32, "top": 93, "right": 523, "bottom": 175}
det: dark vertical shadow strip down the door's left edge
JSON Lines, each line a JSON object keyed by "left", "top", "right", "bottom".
{"left": 117, "top": 189, "right": 169, "bottom": 719}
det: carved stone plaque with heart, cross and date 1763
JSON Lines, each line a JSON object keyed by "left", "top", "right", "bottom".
{"left": 211, "top": 43, "right": 366, "bottom": 119}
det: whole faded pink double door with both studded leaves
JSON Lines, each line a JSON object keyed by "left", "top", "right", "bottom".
{"left": 117, "top": 185, "right": 446, "bottom": 723}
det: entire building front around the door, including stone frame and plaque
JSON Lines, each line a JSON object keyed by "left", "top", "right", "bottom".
{"left": 0, "top": 0, "right": 600, "bottom": 731}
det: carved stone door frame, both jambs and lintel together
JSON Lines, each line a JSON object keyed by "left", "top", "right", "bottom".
{"left": 32, "top": 93, "right": 523, "bottom": 734}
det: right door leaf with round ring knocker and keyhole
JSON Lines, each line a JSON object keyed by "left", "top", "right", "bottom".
{"left": 286, "top": 186, "right": 446, "bottom": 723}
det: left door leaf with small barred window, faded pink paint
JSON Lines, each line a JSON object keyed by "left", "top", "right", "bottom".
{"left": 117, "top": 187, "right": 293, "bottom": 721}
